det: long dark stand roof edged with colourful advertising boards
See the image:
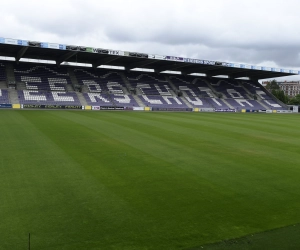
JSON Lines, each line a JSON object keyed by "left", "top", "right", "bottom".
{"left": 0, "top": 38, "right": 300, "bottom": 80}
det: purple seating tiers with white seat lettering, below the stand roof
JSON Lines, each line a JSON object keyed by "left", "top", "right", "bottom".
{"left": 0, "top": 62, "right": 285, "bottom": 110}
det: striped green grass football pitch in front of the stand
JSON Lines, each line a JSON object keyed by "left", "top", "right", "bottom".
{"left": 0, "top": 110, "right": 300, "bottom": 250}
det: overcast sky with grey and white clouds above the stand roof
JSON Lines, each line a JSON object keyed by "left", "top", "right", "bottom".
{"left": 0, "top": 0, "right": 300, "bottom": 80}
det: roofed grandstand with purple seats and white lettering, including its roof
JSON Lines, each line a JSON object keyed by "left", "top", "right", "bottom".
{"left": 0, "top": 38, "right": 299, "bottom": 111}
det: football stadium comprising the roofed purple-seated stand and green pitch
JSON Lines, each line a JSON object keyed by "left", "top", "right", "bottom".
{"left": 0, "top": 38, "right": 300, "bottom": 250}
